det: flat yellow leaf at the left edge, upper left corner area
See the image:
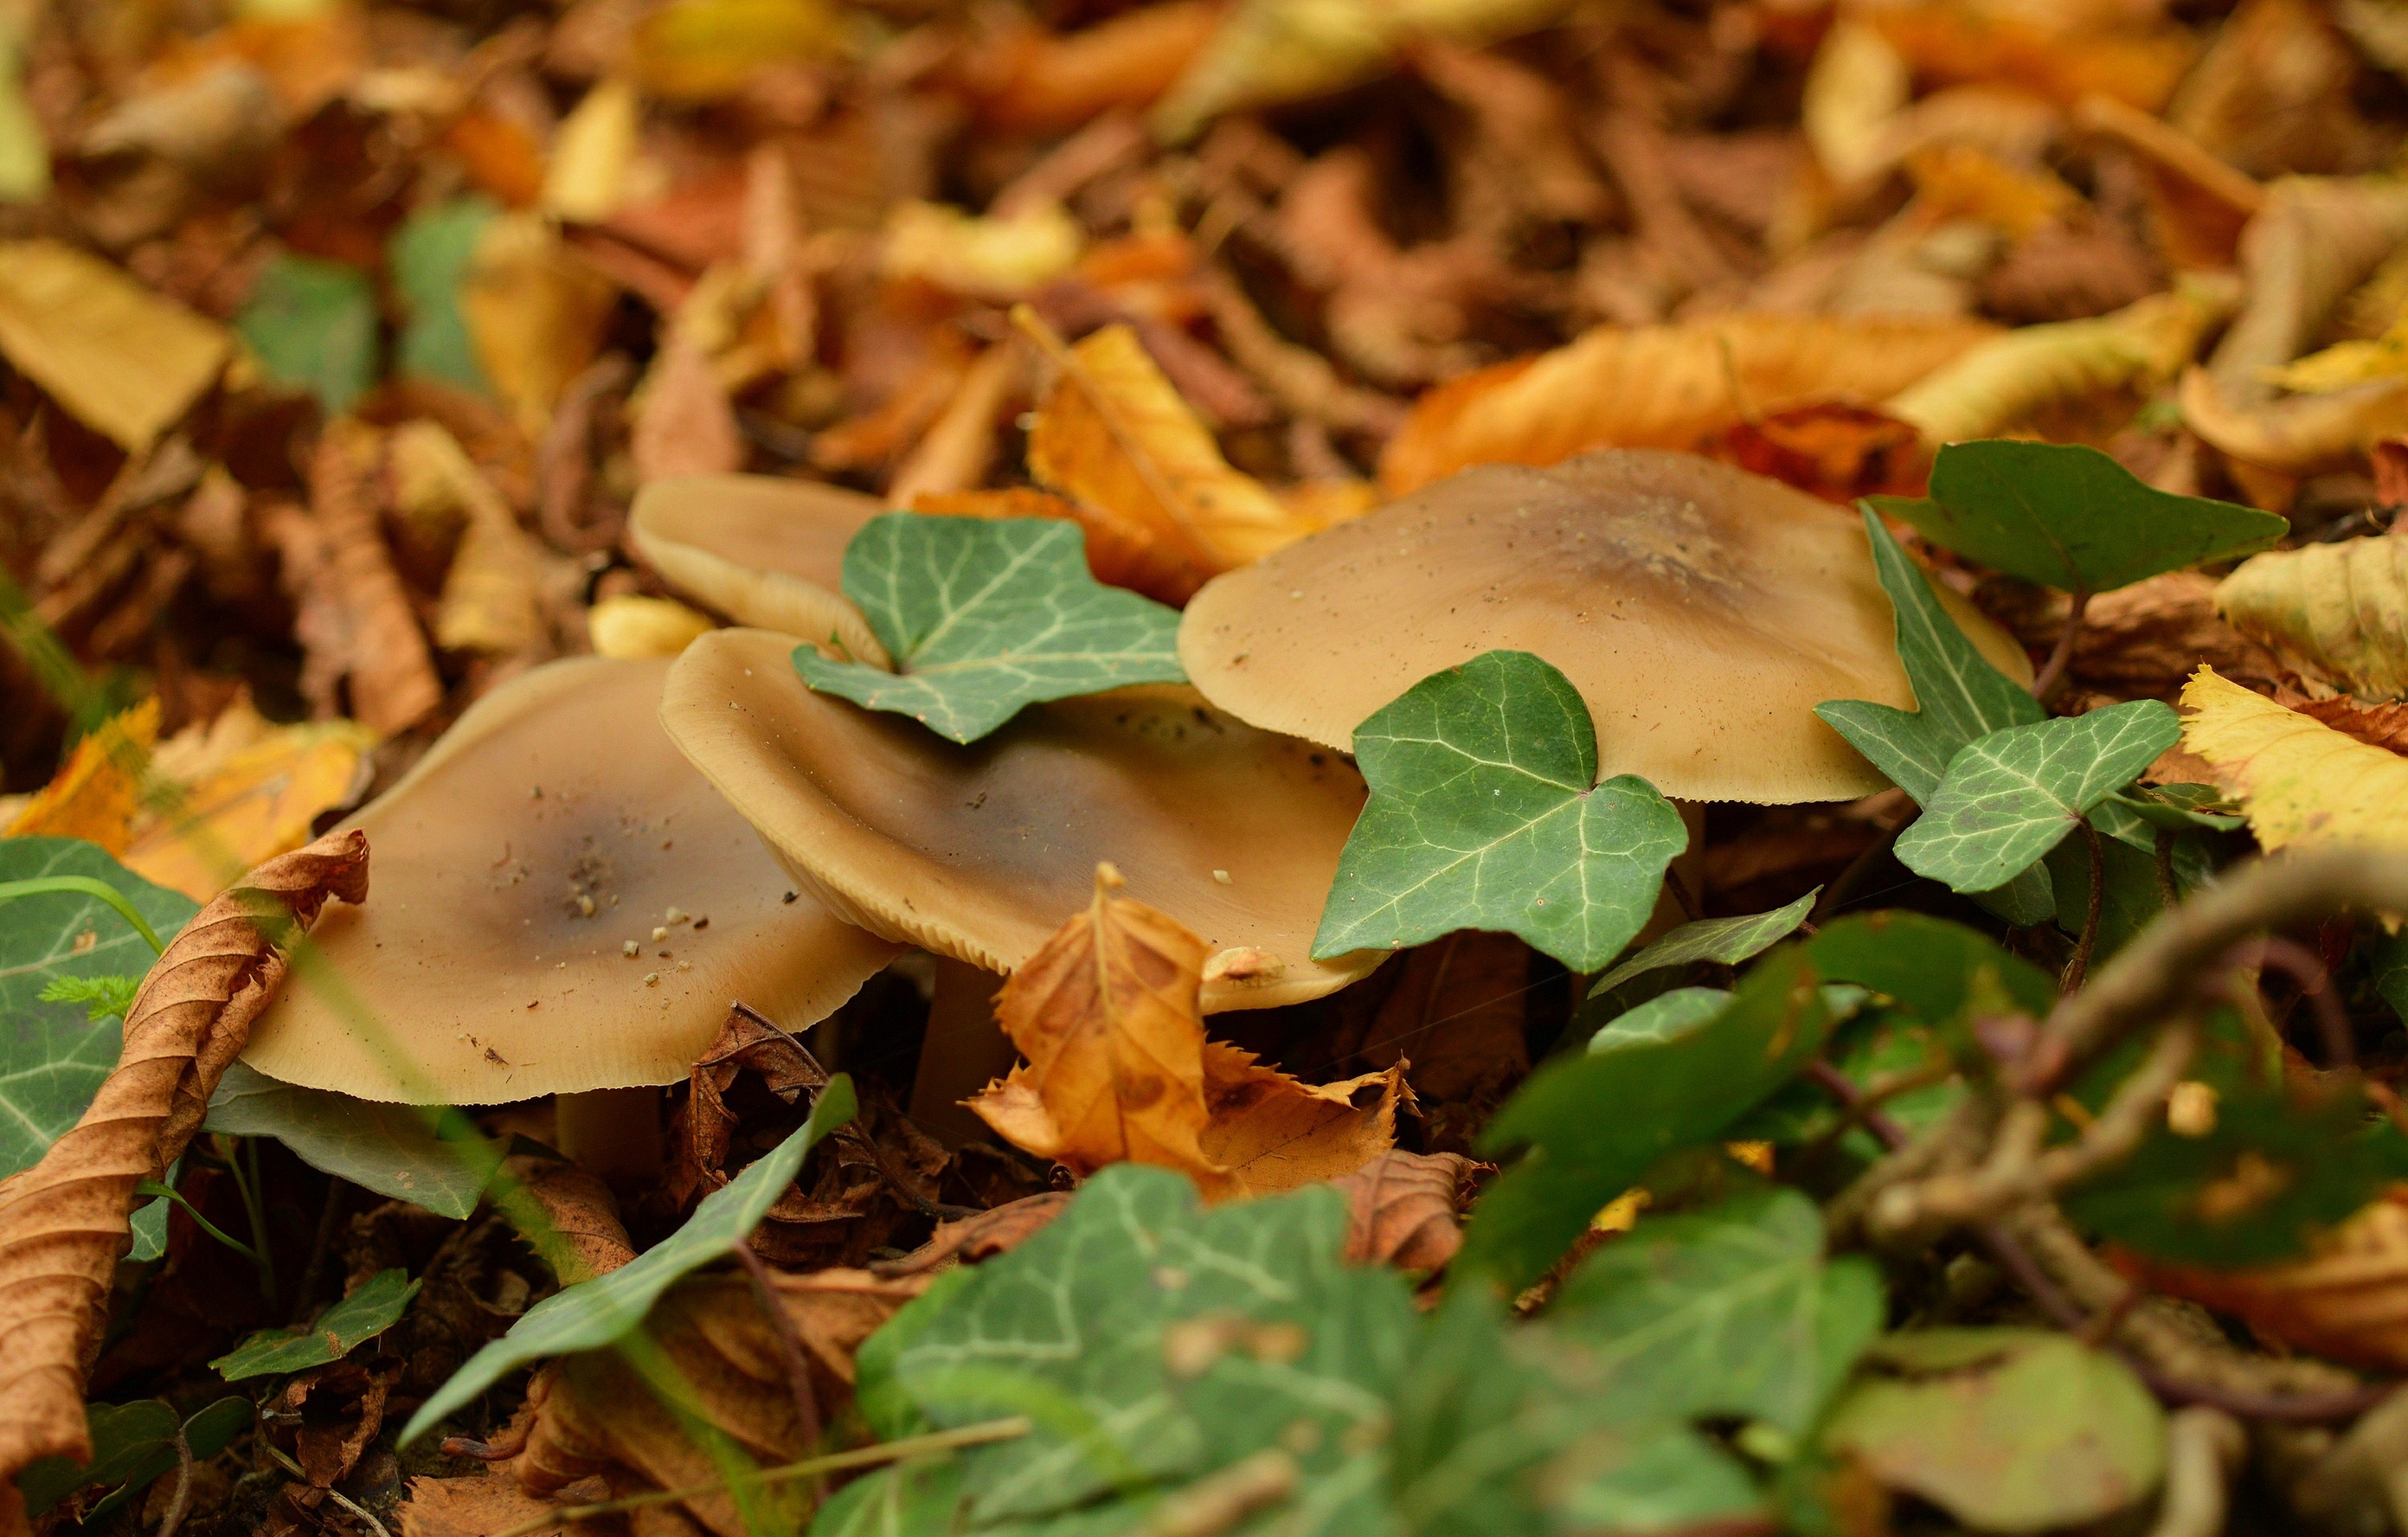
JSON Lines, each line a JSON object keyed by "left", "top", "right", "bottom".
{"left": 0, "top": 241, "right": 234, "bottom": 453}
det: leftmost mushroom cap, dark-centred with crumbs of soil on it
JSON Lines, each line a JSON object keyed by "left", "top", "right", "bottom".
{"left": 243, "top": 657, "right": 896, "bottom": 1106}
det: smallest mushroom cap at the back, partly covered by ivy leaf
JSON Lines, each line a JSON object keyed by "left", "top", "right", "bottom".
{"left": 628, "top": 474, "right": 893, "bottom": 667}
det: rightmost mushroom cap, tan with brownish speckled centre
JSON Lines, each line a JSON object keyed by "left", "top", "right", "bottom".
{"left": 1180, "top": 448, "right": 2032, "bottom": 805}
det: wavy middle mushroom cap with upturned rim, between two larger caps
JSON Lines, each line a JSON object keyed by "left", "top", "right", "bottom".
{"left": 660, "top": 628, "right": 1382, "bottom": 1012}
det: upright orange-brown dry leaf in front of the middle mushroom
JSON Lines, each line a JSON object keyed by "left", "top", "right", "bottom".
{"left": 968, "top": 865, "right": 1404, "bottom": 1200}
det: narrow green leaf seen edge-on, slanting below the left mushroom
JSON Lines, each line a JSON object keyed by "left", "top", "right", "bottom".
{"left": 402, "top": 1072, "right": 852, "bottom": 1446}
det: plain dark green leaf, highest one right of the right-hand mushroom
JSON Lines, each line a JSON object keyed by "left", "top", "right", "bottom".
{"left": 1873, "top": 438, "right": 2290, "bottom": 592}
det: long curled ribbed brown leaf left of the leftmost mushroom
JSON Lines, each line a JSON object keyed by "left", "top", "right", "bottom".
{"left": 0, "top": 832, "right": 368, "bottom": 1530}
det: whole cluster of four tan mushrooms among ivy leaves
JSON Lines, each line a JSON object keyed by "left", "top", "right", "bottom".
{"left": 246, "top": 450, "right": 2030, "bottom": 1166}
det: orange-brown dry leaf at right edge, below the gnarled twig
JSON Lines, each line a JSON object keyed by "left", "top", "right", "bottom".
{"left": 2114, "top": 1190, "right": 2408, "bottom": 1371}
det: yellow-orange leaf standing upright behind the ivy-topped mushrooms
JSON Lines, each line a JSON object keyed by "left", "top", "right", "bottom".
{"left": 1014, "top": 308, "right": 1315, "bottom": 571}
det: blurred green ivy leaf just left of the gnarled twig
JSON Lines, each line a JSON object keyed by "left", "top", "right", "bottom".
{"left": 1548, "top": 1188, "right": 1885, "bottom": 1436}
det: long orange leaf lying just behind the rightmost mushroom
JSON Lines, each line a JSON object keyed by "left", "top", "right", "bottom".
{"left": 1380, "top": 315, "right": 1999, "bottom": 496}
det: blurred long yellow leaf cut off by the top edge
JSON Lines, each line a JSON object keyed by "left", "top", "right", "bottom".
{"left": 1151, "top": 0, "right": 1568, "bottom": 142}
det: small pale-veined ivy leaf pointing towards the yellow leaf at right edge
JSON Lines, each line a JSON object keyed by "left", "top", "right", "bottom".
{"left": 1898, "top": 698, "right": 2182, "bottom": 892}
